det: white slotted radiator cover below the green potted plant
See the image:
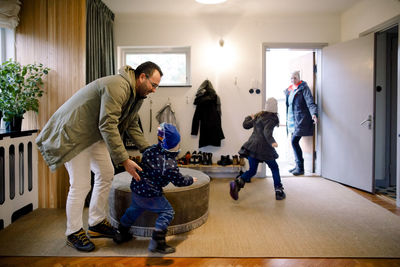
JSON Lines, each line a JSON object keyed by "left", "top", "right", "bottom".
{"left": 0, "top": 131, "right": 38, "bottom": 229}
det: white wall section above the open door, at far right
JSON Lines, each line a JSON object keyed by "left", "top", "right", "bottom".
{"left": 341, "top": 0, "right": 400, "bottom": 41}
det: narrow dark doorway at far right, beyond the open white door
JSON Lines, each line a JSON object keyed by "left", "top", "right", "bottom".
{"left": 374, "top": 25, "right": 398, "bottom": 199}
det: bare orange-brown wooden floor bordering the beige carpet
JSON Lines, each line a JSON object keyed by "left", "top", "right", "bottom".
{"left": 0, "top": 188, "right": 400, "bottom": 267}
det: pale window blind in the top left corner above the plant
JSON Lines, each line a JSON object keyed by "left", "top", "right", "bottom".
{"left": 0, "top": 0, "right": 21, "bottom": 29}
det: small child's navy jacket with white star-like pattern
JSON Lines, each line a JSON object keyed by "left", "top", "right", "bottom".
{"left": 131, "top": 144, "right": 193, "bottom": 197}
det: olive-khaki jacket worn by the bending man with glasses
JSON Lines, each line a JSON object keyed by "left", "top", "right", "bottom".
{"left": 36, "top": 66, "right": 149, "bottom": 170}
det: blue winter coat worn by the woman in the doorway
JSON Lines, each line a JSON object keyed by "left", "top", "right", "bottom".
{"left": 285, "top": 81, "right": 318, "bottom": 136}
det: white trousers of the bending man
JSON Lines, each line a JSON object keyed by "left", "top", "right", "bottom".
{"left": 64, "top": 141, "right": 114, "bottom": 236}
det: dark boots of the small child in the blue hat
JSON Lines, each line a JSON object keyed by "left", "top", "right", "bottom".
{"left": 113, "top": 224, "right": 175, "bottom": 254}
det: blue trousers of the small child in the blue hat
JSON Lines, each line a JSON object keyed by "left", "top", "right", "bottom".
{"left": 121, "top": 192, "right": 175, "bottom": 230}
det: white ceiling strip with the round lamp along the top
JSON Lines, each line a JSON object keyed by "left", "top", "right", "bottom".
{"left": 102, "top": 0, "right": 362, "bottom": 16}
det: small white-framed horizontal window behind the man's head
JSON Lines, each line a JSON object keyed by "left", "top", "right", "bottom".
{"left": 118, "top": 46, "right": 191, "bottom": 87}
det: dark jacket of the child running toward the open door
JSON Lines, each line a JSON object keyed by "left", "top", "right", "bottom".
{"left": 239, "top": 112, "right": 279, "bottom": 161}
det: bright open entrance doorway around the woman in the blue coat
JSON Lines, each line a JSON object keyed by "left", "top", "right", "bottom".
{"left": 263, "top": 48, "right": 317, "bottom": 176}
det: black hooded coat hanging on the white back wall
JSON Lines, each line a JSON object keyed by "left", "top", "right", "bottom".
{"left": 191, "top": 80, "right": 225, "bottom": 148}
